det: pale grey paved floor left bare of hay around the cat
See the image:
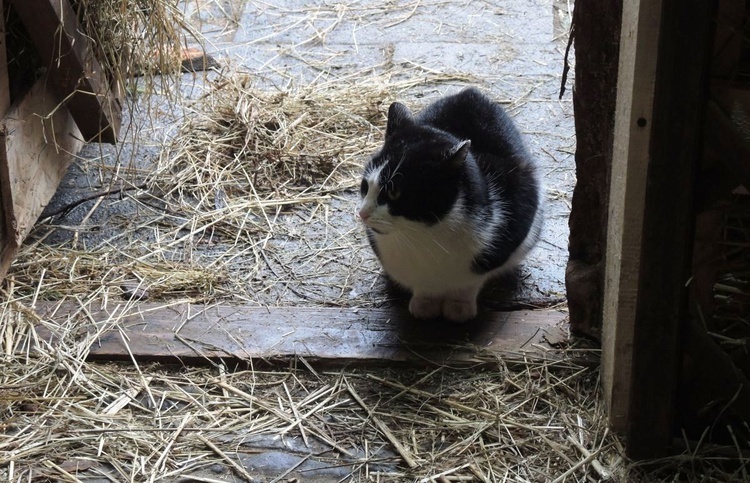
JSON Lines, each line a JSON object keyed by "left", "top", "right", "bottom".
{"left": 38, "top": 0, "right": 575, "bottom": 314}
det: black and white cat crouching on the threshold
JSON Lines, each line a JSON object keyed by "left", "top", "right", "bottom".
{"left": 359, "top": 88, "right": 542, "bottom": 321}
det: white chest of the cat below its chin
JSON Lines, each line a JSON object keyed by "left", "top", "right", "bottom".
{"left": 374, "top": 216, "right": 483, "bottom": 294}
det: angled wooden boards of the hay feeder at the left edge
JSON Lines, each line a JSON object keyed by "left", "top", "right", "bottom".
{"left": 0, "top": 0, "right": 121, "bottom": 280}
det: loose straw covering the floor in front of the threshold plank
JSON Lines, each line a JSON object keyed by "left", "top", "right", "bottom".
{"left": 0, "top": 302, "right": 624, "bottom": 481}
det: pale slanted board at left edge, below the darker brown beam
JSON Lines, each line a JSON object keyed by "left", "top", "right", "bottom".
{"left": 0, "top": 77, "right": 83, "bottom": 279}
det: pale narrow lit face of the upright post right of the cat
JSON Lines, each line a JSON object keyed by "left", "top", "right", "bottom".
{"left": 602, "top": 1, "right": 662, "bottom": 438}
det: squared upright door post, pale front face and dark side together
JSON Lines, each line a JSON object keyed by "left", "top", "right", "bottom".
{"left": 602, "top": 0, "right": 715, "bottom": 459}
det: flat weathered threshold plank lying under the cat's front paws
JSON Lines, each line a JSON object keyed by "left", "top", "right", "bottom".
{"left": 30, "top": 302, "right": 566, "bottom": 363}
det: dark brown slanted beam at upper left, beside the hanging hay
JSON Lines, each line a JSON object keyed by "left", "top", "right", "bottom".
{"left": 10, "top": 0, "right": 121, "bottom": 144}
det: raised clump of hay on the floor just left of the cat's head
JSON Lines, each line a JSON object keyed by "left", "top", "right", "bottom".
{"left": 150, "top": 69, "right": 467, "bottom": 236}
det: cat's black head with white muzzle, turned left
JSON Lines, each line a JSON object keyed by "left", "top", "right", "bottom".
{"left": 359, "top": 102, "right": 470, "bottom": 234}
